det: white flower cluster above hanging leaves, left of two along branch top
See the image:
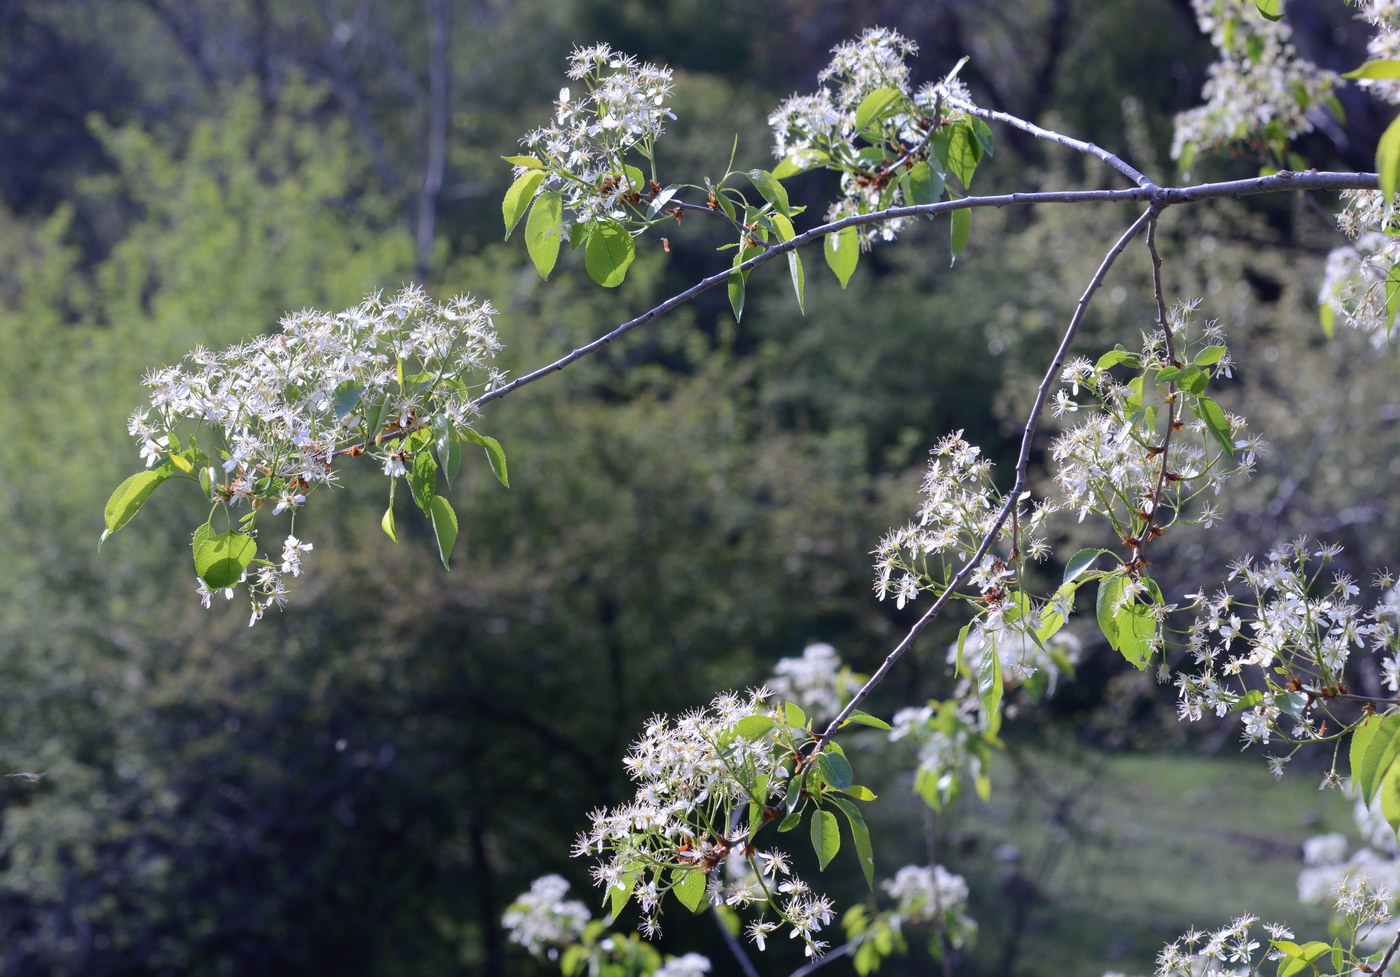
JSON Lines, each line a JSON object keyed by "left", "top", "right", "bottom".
{"left": 515, "top": 43, "right": 676, "bottom": 224}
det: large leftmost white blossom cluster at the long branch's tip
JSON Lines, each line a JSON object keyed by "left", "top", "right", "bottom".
{"left": 123, "top": 286, "right": 500, "bottom": 621}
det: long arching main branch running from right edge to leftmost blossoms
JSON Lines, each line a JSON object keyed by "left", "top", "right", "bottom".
{"left": 473, "top": 171, "right": 1379, "bottom": 407}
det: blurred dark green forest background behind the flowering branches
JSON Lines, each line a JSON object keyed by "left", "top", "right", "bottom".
{"left": 0, "top": 0, "right": 1400, "bottom": 977}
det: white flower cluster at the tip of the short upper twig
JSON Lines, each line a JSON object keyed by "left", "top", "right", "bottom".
{"left": 769, "top": 27, "right": 972, "bottom": 245}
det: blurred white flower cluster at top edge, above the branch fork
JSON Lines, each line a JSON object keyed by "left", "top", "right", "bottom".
{"left": 1172, "top": 0, "right": 1338, "bottom": 165}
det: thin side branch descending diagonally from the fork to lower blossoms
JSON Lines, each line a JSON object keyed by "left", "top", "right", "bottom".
{"left": 812, "top": 206, "right": 1159, "bottom": 753}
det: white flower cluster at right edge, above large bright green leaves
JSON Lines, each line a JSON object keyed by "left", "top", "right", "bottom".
{"left": 1176, "top": 539, "right": 1400, "bottom": 744}
